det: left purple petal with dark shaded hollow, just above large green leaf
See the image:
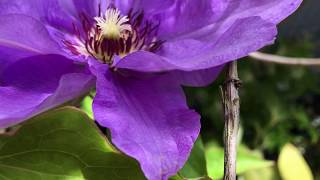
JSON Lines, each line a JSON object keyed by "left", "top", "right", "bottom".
{"left": 0, "top": 55, "right": 94, "bottom": 128}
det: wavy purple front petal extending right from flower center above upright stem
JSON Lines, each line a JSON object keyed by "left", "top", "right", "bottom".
{"left": 116, "top": 17, "right": 277, "bottom": 72}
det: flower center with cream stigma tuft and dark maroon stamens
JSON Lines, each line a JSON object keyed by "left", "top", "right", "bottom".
{"left": 63, "top": 7, "right": 163, "bottom": 66}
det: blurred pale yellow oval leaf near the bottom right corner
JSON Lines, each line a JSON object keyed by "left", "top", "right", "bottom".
{"left": 278, "top": 144, "right": 313, "bottom": 180}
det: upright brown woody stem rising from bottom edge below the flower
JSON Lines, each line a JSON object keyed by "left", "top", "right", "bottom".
{"left": 221, "top": 61, "right": 241, "bottom": 180}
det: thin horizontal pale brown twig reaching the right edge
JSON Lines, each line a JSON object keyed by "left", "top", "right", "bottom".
{"left": 249, "top": 52, "right": 320, "bottom": 66}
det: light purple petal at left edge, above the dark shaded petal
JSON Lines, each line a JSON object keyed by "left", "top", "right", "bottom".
{"left": 0, "top": 15, "right": 59, "bottom": 56}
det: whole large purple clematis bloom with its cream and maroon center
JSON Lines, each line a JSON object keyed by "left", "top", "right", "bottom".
{"left": 0, "top": 0, "right": 301, "bottom": 180}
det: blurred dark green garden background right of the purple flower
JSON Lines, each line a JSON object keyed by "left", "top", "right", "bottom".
{"left": 186, "top": 0, "right": 320, "bottom": 180}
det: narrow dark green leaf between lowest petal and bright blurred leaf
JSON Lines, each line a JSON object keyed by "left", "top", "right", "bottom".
{"left": 179, "top": 137, "right": 208, "bottom": 179}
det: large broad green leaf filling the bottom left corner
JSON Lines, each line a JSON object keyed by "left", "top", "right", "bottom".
{"left": 0, "top": 107, "right": 145, "bottom": 180}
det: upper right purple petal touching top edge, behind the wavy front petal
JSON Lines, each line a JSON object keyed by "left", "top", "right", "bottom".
{"left": 157, "top": 0, "right": 302, "bottom": 41}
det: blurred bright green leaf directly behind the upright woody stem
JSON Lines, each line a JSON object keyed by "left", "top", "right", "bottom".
{"left": 206, "top": 143, "right": 273, "bottom": 179}
